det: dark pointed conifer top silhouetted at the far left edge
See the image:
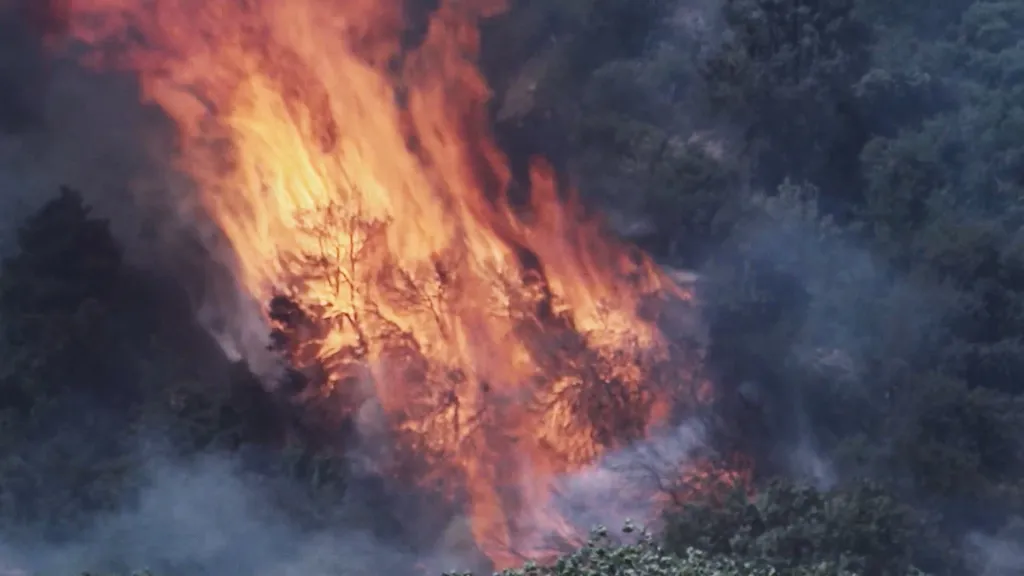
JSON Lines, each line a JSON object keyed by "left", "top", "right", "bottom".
{"left": 0, "top": 189, "right": 121, "bottom": 401}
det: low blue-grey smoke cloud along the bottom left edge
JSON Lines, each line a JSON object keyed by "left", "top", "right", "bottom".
{"left": 0, "top": 448, "right": 425, "bottom": 576}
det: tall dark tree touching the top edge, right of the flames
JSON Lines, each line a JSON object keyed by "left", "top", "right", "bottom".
{"left": 703, "top": 0, "right": 871, "bottom": 199}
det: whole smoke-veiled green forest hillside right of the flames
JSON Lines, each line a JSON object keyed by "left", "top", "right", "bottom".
{"left": 524, "top": 0, "right": 1024, "bottom": 570}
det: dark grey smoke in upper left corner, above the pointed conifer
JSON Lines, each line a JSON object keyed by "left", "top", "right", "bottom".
{"left": 0, "top": 0, "right": 183, "bottom": 251}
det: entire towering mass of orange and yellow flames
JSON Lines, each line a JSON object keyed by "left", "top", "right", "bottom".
{"left": 54, "top": 0, "right": 720, "bottom": 568}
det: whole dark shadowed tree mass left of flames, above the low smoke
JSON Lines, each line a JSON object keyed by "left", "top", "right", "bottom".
{"left": 0, "top": 189, "right": 284, "bottom": 539}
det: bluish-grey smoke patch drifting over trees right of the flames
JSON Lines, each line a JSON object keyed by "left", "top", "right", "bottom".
{"left": 701, "top": 184, "right": 949, "bottom": 489}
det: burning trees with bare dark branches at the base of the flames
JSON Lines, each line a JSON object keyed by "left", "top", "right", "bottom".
{"left": 260, "top": 187, "right": 712, "bottom": 556}
